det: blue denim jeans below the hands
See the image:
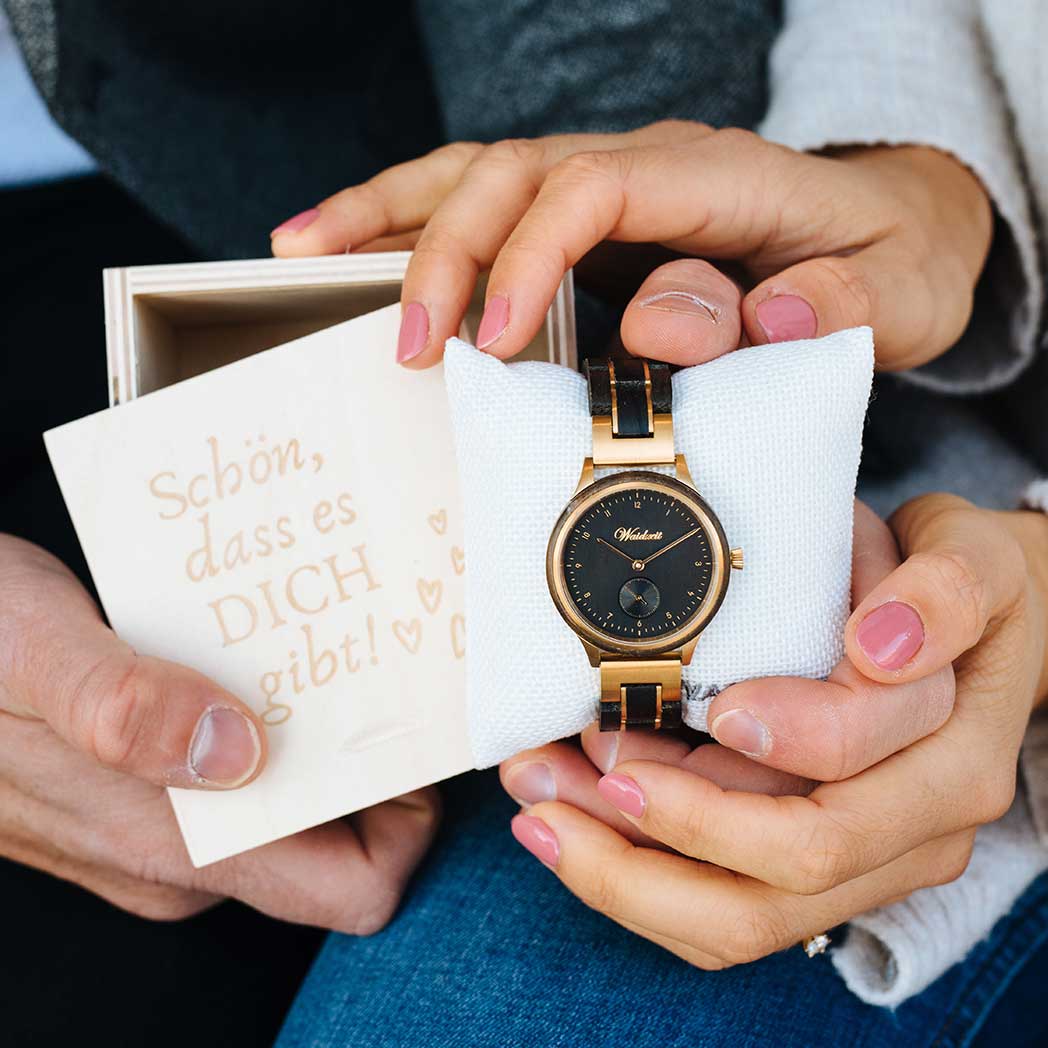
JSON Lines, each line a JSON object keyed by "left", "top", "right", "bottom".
{"left": 278, "top": 772, "right": 1048, "bottom": 1048}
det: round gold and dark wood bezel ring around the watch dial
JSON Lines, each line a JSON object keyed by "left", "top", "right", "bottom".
{"left": 546, "top": 470, "right": 730, "bottom": 655}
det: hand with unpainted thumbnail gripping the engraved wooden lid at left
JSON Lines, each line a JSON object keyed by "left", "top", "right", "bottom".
{"left": 0, "top": 536, "right": 438, "bottom": 934}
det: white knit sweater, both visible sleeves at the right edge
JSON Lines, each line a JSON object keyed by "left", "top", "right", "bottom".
{"left": 761, "top": 0, "right": 1048, "bottom": 1006}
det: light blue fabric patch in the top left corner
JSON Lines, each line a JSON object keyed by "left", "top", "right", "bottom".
{"left": 0, "top": 12, "right": 94, "bottom": 189}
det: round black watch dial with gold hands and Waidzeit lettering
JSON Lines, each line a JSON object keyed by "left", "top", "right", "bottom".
{"left": 562, "top": 486, "right": 714, "bottom": 640}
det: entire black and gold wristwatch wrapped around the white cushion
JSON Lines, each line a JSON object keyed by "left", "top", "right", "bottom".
{"left": 546, "top": 359, "right": 742, "bottom": 732}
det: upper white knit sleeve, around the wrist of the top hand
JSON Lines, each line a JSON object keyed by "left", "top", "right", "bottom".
{"left": 761, "top": 0, "right": 1043, "bottom": 393}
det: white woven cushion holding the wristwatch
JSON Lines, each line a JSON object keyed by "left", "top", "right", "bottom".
{"left": 444, "top": 328, "right": 873, "bottom": 767}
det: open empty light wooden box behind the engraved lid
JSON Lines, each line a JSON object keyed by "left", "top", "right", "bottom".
{"left": 105, "top": 252, "right": 576, "bottom": 406}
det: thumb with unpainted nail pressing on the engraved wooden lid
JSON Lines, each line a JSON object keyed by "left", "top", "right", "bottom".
{"left": 0, "top": 540, "right": 265, "bottom": 789}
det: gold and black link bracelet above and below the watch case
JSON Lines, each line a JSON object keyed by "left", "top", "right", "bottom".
{"left": 586, "top": 359, "right": 683, "bottom": 732}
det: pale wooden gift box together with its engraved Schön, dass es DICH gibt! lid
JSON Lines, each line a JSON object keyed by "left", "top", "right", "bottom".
{"left": 45, "top": 255, "right": 573, "bottom": 866}
